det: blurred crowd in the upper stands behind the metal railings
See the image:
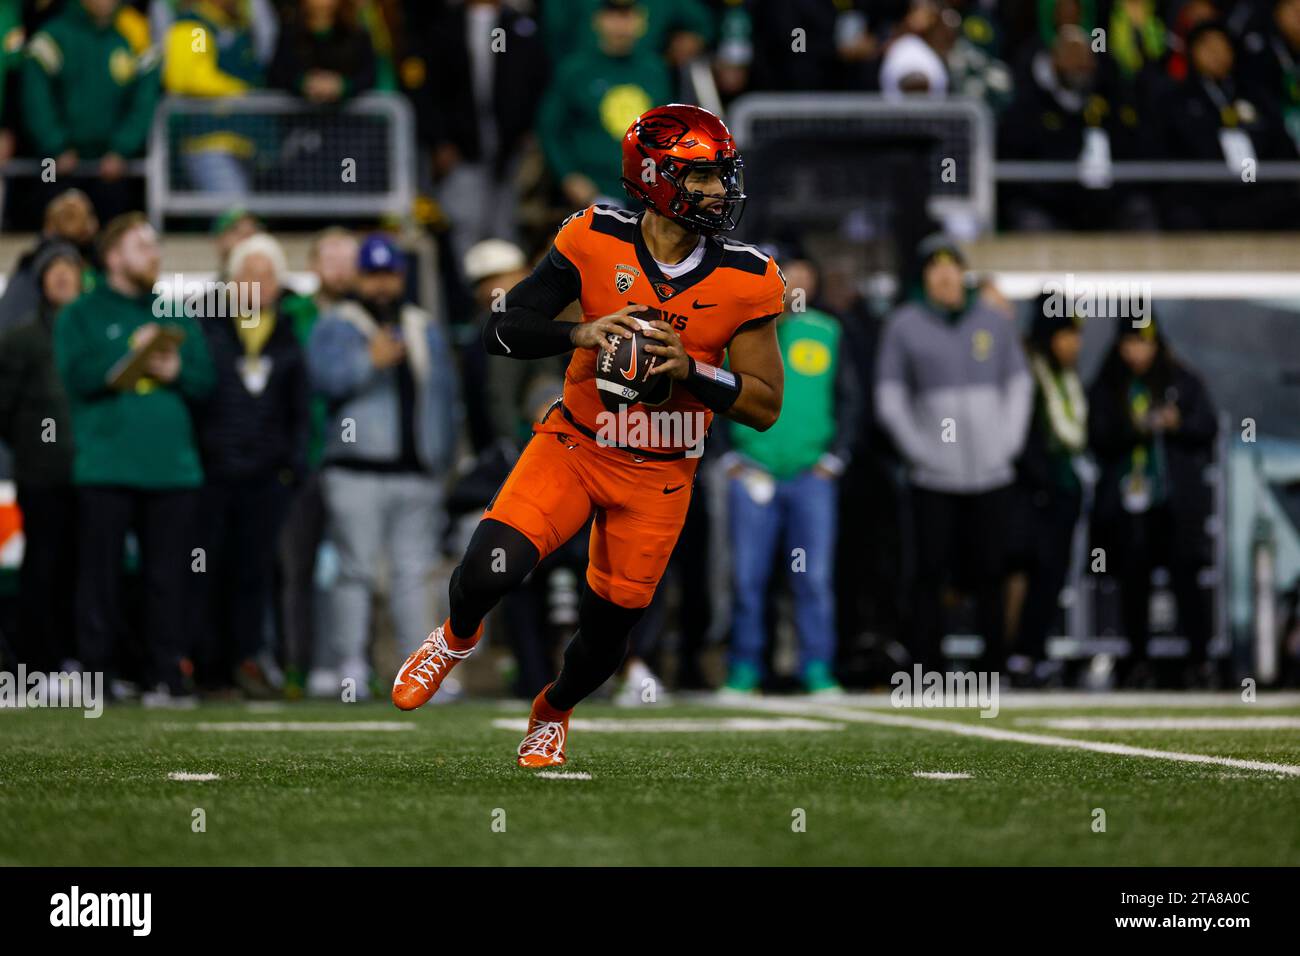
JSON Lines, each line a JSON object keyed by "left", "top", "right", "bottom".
{"left": 0, "top": 0, "right": 1300, "bottom": 231}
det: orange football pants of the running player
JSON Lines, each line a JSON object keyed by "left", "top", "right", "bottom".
{"left": 484, "top": 407, "right": 699, "bottom": 607}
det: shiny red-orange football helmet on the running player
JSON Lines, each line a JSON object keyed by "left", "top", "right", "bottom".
{"left": 623, "top": 103, "right": 745, "bottom": 233}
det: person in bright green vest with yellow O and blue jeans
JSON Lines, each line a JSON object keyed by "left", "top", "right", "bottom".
{"left": 723, "top": 256, "right": 861, "bottom": 695}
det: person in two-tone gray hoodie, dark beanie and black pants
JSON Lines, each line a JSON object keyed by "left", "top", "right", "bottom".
{"left": 875, "top": 235, "right": 1034, "bottom": 669}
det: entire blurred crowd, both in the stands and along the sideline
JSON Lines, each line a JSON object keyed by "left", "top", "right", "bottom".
{"left": 0, "top": 0, "right": 1248, "bottom": 700}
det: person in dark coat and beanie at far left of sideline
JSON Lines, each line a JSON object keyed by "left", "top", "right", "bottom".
{"left": 0, "top": 239, "right": 82, "bottom": 670}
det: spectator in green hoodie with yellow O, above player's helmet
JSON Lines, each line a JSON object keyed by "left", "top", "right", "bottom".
{"left": 537, "top": 0, "right": 672, "bottom": 208}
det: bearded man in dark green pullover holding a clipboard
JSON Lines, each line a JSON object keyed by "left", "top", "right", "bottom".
{"left": 55, "top": 212, "right": 216, "bottom": 704}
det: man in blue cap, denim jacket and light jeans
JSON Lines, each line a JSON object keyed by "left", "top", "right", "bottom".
{"left": 307, "top": 234, "right": 460, "bottom": 697}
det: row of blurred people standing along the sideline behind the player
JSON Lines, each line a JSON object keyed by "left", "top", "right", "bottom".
{"left": 0, "top": 190, "right": 1219, "bottom": 702}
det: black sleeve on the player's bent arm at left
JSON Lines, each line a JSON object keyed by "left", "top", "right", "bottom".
{"left": 484, "top": 246, "right": 582, "bottom": 359}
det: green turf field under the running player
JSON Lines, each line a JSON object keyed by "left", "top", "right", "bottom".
{"left": 0, "top": 695, "right": 1300, "bottom": 866}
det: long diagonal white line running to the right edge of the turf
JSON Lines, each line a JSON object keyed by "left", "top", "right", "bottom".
{"left": 717, "top": 700, "right": 1300, "bottom": 777}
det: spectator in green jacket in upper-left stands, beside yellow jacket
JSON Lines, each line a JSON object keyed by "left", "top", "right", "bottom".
{"left": 22, "top": 0, "right": 159, "bottom": 217}
